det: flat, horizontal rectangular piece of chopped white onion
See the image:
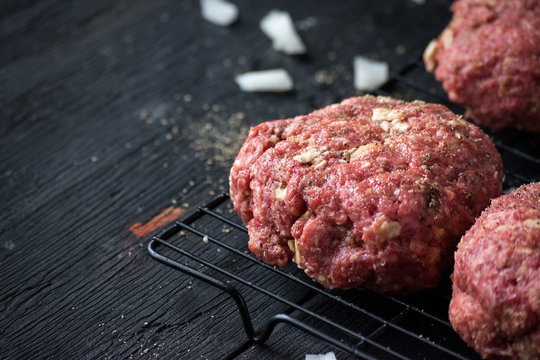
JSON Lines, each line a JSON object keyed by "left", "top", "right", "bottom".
{"left": 234, "top": 69, "right": 293, "bottom": 92}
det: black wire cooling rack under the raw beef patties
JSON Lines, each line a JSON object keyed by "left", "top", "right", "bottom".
{"left": 148, "top": 60, "right": 540, "bottom": 359}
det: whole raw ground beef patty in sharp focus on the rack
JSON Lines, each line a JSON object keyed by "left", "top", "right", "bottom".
{"left": 230, "top": 96, "right": 502, "bottom": 293}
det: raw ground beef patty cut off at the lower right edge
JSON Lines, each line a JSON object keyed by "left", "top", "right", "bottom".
{"left": 449, "top": 183, "right": 540, "bottom": 359}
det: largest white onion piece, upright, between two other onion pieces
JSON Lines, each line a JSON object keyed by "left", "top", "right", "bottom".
{"left": 259, "top": 10, "right": 306, "bottom": 55}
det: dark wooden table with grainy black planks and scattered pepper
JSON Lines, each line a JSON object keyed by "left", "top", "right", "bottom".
{"left": 0, "top": 0, "right": 538, "bottom": 359}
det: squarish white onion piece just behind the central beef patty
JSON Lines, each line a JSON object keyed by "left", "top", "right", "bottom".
{"left": 354, "top": 56, "right": 390, "bottom": 91}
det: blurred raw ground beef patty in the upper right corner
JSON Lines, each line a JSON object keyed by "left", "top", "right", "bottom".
{"left": 424, "top": 0, "right": 540, "bottom": 131}
